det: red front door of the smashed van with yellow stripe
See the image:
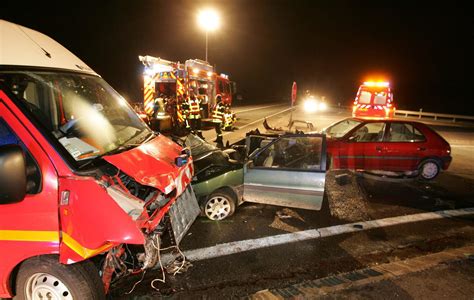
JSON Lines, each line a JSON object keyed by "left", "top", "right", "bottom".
{"left": 0, "top": 95, "right": 59, "bottom": 294}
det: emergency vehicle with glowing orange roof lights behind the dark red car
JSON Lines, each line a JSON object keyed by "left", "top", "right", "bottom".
{"left": 352, "top": 81, "right": 395, "bottom": 118}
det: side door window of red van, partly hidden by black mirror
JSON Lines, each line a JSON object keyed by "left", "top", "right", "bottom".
{"left": 0, "top": 118, "right": 41, "bottom": 194}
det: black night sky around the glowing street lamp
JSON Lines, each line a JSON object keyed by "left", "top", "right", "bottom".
{"left": 0, "top": 0, "right": 474, "bottom": 115}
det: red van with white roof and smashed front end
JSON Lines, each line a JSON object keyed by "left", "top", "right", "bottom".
{"left": 0, "top": 20, "right": 199, "bottom": 299}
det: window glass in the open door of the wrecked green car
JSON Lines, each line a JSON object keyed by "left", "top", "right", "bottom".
{"left": 254, "top": 136, "right": 322, "bottom": 170}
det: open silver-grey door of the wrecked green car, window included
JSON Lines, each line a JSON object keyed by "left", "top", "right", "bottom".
{"left": 244, "top": 134, "right": 326, "bottom": 210}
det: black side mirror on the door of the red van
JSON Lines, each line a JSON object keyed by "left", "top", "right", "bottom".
{"left": 0, "top": 145, "right": 26, "bottom": 204}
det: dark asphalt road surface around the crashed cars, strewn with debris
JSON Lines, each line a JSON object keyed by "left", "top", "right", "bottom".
{"left": 111, "top": 104, "right": 474, "bottom": 299}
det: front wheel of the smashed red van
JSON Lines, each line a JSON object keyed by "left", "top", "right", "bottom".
{"left": 15, "top": 256, "right": 105, "bottom": 300}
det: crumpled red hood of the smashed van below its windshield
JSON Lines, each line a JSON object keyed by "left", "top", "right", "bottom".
{"left": 104, "top": 135, "right": 192, "bottom": 195}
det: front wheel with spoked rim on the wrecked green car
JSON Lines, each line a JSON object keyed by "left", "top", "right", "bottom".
{"left": 203, "top": 191, "right": 236, "bottom": 221}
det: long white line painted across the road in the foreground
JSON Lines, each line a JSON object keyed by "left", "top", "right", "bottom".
{"left": 163, "top": 207, "right": 474, "bottom": 262}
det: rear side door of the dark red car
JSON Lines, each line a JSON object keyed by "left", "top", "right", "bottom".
{"left": 384, "top": 122, "right": 427, "bottom": 171}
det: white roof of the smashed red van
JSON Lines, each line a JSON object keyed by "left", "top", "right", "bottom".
{"left": 0, "top": 19, "right": 98, "bottom": 75}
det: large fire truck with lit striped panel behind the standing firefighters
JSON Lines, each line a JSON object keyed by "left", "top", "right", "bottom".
{"left": 139, "top": 55, "right": 236, "bottom": 129}
